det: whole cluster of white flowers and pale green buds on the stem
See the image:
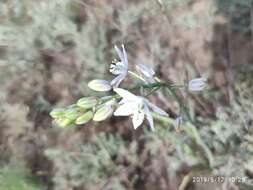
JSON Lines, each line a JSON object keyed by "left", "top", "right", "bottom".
{"left": 50, "top": 45, "right": 207, "bottom": 131}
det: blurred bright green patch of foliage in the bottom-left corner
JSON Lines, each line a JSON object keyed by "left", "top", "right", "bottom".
{"left": 0, "top": 166, "right": 43, "bottom": 190}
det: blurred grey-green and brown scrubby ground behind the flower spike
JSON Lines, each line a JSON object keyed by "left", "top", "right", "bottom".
{"left": 0, "top": 0, "right": 253, "bottom": 190}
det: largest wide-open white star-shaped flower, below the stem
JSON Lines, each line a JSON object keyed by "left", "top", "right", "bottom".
{"left": 114, "top": 88, "right": 168, "bottom": 131}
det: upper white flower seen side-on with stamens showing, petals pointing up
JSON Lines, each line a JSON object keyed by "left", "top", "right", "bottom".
{"left": 110, "top": 44, "right": 128, "bottom": 88}
